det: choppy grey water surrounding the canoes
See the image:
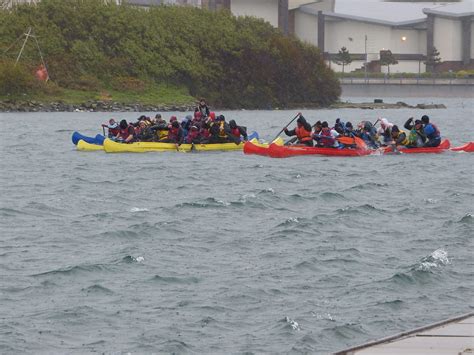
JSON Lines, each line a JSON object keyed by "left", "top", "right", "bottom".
{"left": 0, "top": 99, "right": 474, "bottom": 353}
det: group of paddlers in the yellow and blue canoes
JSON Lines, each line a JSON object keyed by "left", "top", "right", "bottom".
{"left": 102, "top": 99, "right": 247, "bottom": 145}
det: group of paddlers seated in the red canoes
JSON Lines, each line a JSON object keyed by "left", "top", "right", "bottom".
{"left": 280, "top": 113, "right": 441, "bottom": 149}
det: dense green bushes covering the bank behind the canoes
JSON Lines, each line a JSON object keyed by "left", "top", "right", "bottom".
{"left": 0, "top": 0, "right": 340, "bottom": 108}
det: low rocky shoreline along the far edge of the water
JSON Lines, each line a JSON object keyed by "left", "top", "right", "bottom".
{"left": 0, "top": 100, "right": 446, "bottom": 112}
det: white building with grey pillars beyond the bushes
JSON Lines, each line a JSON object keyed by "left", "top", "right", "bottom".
{"left": 229, "top": 0, "right": 474, "bottom": 72}
